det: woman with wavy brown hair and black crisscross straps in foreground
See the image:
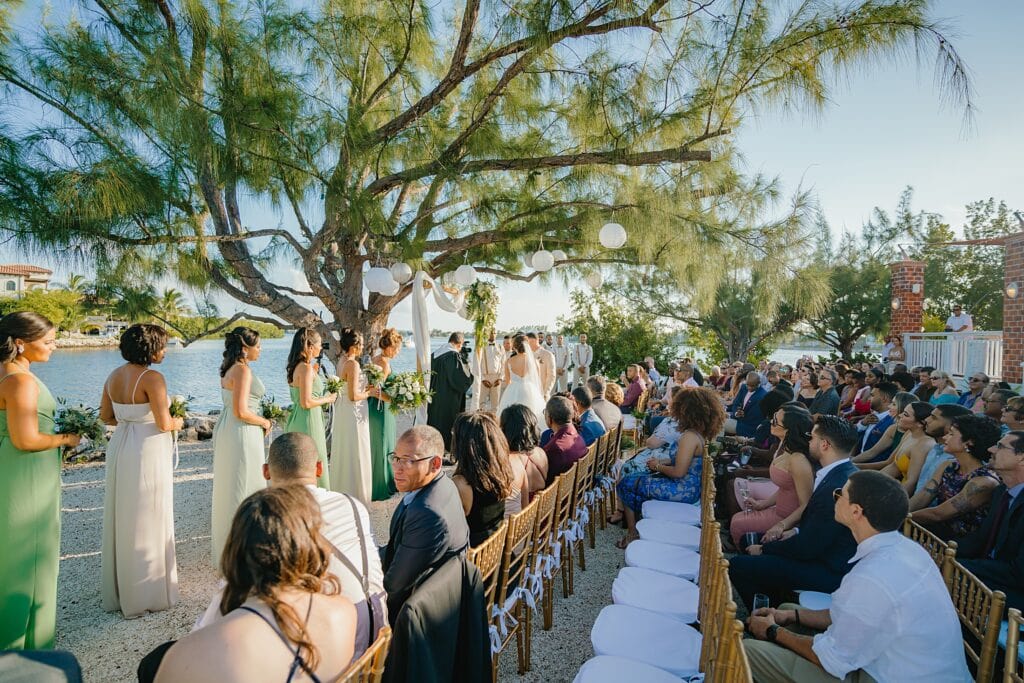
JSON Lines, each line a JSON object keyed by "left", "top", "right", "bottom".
{"left": 149, "top": 486, "right": 356, "bottom": 683}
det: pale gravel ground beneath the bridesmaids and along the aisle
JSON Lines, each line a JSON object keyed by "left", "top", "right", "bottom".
{"left": 57, "top": 441, "right": 623, "bottom": 683}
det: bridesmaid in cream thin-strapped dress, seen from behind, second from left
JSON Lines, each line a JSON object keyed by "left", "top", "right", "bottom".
{"left": 99, "top": 325, "right": 184, "bottom": 618}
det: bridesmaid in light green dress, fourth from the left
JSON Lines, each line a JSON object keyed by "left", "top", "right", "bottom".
{"left": 285, "top": 328, "right": 338, "bottom": 488}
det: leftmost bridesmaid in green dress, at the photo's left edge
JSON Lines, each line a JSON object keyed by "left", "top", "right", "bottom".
{"left": 0, "top": 311, "right": 81, "bottom": 650}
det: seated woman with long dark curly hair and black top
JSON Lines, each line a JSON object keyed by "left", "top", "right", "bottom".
{"left": 452, "top": 412, "right": 529, "bottom": 547}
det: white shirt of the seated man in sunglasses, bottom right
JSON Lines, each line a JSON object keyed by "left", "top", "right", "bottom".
{"left": 812, "top": 531, "right": 974, "bottom": 683}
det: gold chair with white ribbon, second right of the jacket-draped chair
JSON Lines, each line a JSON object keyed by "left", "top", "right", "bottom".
{"left": 490, "top": 499, "right": 540, "bottom": 681}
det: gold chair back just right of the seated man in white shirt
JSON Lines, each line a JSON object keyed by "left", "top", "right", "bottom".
{"left": 942, "top": 548, "right": 1007, "bottom": 683}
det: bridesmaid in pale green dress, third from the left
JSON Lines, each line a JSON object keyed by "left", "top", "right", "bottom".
{"left": 210, "top": 327, "right": 272, "bottom": 569}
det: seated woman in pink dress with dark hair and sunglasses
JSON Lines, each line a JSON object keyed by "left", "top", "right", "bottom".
{"left": 729, "top": 403, "right": 814, "bottom": 548}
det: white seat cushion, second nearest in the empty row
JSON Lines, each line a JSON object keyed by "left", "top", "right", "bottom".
{"left": 590, "top": 605, "right": 700, "bottom": 681}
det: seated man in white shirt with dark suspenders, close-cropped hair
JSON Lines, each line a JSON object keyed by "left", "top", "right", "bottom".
{"left": 196, "top": 432, "right": 388, "bottom": 657}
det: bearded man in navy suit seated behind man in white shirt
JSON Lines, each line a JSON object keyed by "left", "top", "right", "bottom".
{"left": 729, "top": 416, "right": 858, "bottom": 607}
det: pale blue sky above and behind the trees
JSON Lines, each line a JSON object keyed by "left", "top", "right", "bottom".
{"left": 0, "top": 0, "right": 1024, "bottom": 330}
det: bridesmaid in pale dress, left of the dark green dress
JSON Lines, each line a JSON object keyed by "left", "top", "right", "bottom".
{"left": 331, "top": 328, "right": 381, "bottom": 505}
